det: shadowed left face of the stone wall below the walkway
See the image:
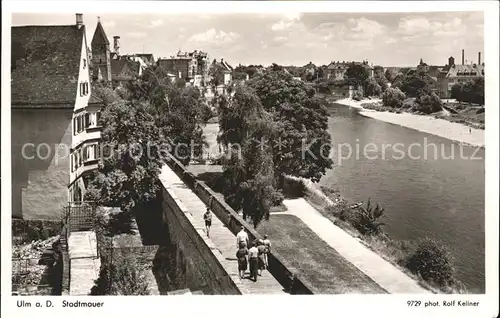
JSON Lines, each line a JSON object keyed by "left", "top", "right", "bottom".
{"left": 155, "top": 187, "right": 241, "bottom": 295}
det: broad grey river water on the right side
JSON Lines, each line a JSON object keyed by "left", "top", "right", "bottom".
{"left": 320, "top": 104, "right": 485, "bottom": 293}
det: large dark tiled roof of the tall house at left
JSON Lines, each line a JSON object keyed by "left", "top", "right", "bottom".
{"left": 11, "top": 25, "right": 85, "bottom": 104}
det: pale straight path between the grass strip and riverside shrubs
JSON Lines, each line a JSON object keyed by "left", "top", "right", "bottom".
{"left": 283, "top": 198, "right": 431, "bottom": 294}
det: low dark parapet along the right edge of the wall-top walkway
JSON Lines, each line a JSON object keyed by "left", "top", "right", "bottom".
{"left": 167, "top": 156, "right": 313, "bottom": 294}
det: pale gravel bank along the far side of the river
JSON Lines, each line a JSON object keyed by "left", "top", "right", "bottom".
{"left": 335, "top": 98, "right": 485, "bottom": 148}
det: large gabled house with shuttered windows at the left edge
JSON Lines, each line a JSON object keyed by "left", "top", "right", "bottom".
{"left": 11, "top": 14, "right": 103, "bottom": 218}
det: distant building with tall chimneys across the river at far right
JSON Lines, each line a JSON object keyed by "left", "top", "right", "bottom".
{"left": 437, "top": 50, "right": 484, "bottom": 98}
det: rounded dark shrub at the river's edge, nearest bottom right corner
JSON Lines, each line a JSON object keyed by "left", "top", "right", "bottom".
{"left": 405, "top": 238, "right": 454, "bottom": 287}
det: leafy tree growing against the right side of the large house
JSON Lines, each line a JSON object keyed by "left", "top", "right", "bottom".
{"left": 86, "top": 100, "right": 163, "bottom": 213}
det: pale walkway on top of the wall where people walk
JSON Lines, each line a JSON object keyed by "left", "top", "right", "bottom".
{"left": 160, "top": 165, "right": 285, "bottom": 294}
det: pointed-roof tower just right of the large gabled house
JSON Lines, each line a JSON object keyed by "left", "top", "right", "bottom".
{"left": 91, "top": 17, "right": 111, "bottom": 83}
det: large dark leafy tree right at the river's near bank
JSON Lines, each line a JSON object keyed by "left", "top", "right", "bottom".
{"left": 248, "top": 72, "right": 332, "bottom": 186}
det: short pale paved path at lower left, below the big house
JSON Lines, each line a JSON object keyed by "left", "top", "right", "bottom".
{"left": 68, "top": 231, "right": 101, "bottom": 296}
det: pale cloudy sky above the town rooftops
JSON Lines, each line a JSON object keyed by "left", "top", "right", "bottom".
{"left": 12, "top": 11, "right": 485, "bottom": 66}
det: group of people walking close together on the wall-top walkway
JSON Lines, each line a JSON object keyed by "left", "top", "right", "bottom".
{"left": 236, "top": 226, "right": 271, "bottom": 282}
